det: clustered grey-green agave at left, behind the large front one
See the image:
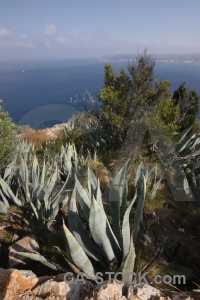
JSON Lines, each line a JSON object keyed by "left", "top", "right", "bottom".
{"left": 0, "top": 155, "right": 70, "bottom": 228}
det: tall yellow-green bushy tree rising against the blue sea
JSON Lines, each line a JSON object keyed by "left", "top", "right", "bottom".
{"left": 98, "top": 50, "right": 179, "bottom": 142}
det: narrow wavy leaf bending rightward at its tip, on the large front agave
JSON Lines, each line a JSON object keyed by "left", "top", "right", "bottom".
{"left": 122, "top": 193, "right": 137, "bottom": 259}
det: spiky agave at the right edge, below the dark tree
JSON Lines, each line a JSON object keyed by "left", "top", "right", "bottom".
{"left": 160, "top": 127, "right": 200, "bottom": 206}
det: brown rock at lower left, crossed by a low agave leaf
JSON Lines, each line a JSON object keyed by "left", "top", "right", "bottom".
{"left": 9, "top": 234, "right": 40, "bottom": 268}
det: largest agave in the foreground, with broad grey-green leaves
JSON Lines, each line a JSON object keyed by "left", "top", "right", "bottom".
{"left": 63, "top": 164, "right": 160, "bottom": 284}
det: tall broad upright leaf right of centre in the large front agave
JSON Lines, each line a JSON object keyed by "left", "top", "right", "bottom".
{"left": 109, "top": 163, "right": 127, "bottom": 245}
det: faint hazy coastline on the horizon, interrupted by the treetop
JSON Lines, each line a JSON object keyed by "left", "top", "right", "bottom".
{"left": 91, "top": 53, "right": 200, "bottom": 64}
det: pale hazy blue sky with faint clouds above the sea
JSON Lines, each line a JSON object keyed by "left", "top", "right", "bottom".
{"left": 0, "top": 0, "right": 200, "bottom": 60}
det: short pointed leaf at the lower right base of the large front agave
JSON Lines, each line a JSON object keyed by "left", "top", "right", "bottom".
{"left": 122, "top": 234, "right": 136, "bottom": 286}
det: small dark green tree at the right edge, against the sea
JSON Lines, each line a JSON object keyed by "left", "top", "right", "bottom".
{"left": 172, "top": 82, "right": 200, "bottom": 131}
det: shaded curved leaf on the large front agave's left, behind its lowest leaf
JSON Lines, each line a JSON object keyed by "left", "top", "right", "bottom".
{"left": 68, "top": 188, "right": 105, "bottom": 265}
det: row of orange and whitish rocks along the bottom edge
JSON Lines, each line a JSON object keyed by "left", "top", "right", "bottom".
{"left": 0, "top": 268, "right": 200, "bottom": 300}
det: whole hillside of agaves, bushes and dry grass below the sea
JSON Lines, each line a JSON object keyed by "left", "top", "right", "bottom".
{"left": 0, "top": 51, "right": 200, "bottom": 291}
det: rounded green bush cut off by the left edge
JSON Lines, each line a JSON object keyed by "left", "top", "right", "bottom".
{"left": 0, "top": 100, "right": 16, "bottom": 171}
